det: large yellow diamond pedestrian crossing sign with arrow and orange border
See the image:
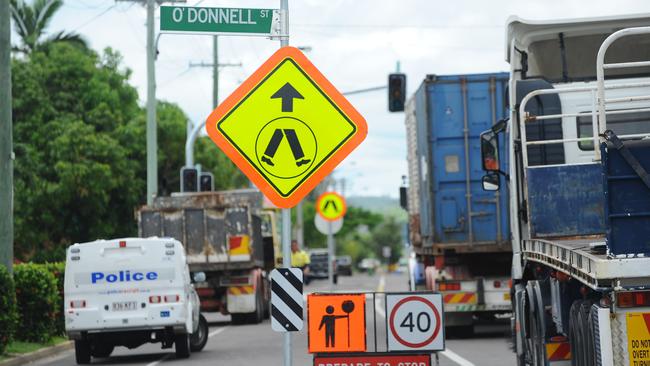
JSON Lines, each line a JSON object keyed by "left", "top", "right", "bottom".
{"left": 206, "top": 47, "right": 368, "bottom": 208}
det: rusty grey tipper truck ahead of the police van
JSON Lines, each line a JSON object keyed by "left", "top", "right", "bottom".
{"left": 136, "top": 188, "right": 280, "bottom": 324}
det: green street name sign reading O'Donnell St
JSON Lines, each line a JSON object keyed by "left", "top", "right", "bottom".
{"left": 160, "top": 6, "right": 280, "bottom": 36}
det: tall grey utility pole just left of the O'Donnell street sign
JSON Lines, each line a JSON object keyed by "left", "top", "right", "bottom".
{"left": 147, "top": 0, "right": 158, "bottom": 205}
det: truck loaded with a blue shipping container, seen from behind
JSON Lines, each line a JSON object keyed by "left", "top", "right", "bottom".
{"left": 405, "top": 72, "right": 511, "bottom": 336}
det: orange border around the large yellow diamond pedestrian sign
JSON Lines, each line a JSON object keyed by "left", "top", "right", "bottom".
{"left": 205, "top": 47, "right": 368, "bottom": 208}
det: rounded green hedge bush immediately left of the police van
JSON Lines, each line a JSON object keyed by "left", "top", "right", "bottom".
{"left": 14, "top": 263, "right": 59, "bottom": 343}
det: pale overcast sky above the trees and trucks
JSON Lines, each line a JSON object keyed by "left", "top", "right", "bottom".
{"left": 36, "top": 0, "right": 650, "bottom": 196}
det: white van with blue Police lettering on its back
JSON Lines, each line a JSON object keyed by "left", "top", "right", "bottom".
{"left": 64, "top": 238, "right": 208, "bottom": 364}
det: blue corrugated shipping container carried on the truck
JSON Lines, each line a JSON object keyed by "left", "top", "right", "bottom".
{"left": 415, "top": 73, "right": 510, "bottom": 247}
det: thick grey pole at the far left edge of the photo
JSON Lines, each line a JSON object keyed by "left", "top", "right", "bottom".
{"left": 0, "top": 0, "right": 14, "bottom": 273}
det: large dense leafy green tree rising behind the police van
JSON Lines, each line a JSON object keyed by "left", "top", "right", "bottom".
{"left": 12, "top": 43, "right": 145, "bottom": 261}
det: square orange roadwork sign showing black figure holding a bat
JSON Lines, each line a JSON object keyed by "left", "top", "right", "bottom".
{"left": 307, "top": 294, "right": 366, "bottom": 353}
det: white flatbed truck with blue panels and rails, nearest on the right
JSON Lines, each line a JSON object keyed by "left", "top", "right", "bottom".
{"left": 481, "top": 14, "right": 650, "bottom": 366}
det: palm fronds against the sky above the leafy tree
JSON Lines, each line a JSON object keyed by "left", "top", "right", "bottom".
{"left": 11, "top": 0, "right": 87, "bottom": 54}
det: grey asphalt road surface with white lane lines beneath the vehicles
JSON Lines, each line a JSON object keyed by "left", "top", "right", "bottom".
{"left": 32, "top": 274, "right": 515, "bottom": 366}
